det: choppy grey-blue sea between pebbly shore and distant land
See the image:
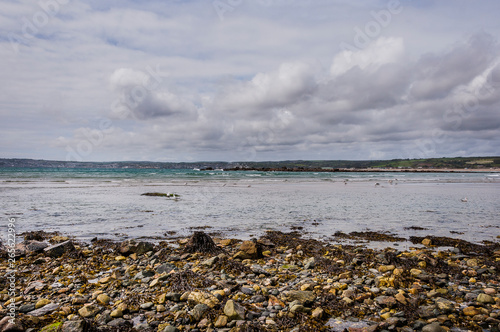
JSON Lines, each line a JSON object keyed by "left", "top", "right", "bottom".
{"left": 0, "top": 168, "right": 500, "bottom": 246}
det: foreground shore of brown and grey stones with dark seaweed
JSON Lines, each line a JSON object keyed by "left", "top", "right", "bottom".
{"left": 0, "top": 231, "right": 500, "bottom": 332}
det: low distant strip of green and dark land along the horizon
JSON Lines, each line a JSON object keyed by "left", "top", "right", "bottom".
{"left": 0, "top": 156, "right": 500, "bottom": 173}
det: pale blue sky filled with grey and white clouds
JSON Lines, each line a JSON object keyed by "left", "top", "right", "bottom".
{"left": 0, "top": 0, "right": 500, "bottom": 162}
